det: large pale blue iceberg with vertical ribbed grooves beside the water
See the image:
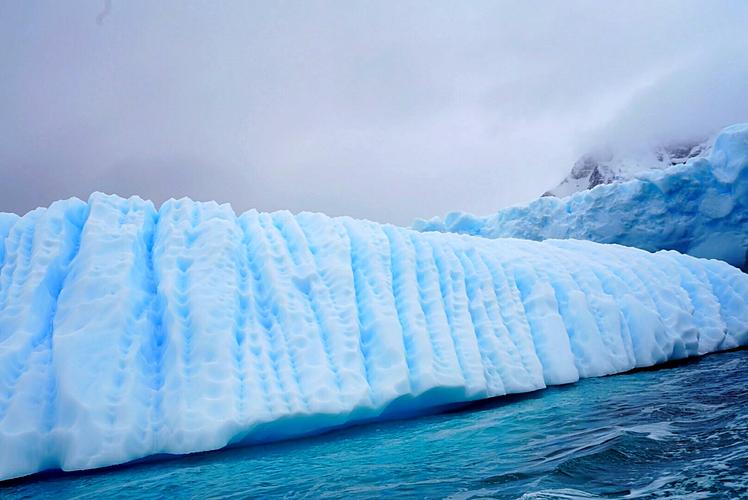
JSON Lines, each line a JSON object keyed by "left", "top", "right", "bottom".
{"left": 0, "top": 193, "right": 748, "bottom": 479}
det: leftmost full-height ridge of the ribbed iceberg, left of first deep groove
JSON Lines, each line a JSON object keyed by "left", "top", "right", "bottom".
{"left": 0, "top": 200, "right": 88, "bottom": 470}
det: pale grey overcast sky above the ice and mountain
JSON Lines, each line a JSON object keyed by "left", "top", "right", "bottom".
{"left": 0, "top": 0, "right": 748, "bottom": 224}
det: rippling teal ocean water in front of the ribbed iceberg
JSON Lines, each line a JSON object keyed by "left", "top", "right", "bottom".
{"left": 0, "top": 350, "right": 748, "bottom": 499}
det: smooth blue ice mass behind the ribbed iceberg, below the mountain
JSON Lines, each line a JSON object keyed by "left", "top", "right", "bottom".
{"left": 414, "top": 124, "right": 748, "bottom": 270}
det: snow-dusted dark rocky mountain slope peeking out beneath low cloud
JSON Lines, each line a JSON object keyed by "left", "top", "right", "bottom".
{"left": 543, "top": 139, "right": 713, "bottom": 198}
